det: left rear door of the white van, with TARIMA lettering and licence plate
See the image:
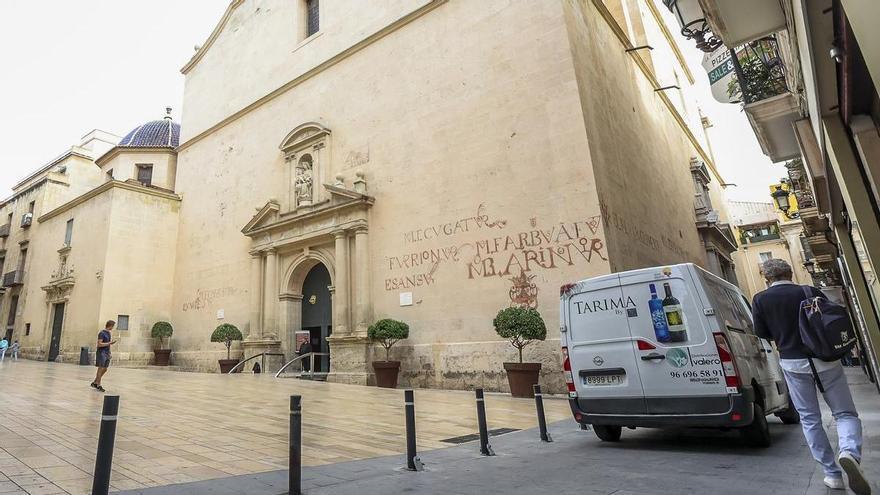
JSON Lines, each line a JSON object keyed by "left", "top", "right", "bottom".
{"left": 563, "top": 274, "right": 647, "bottom": 414}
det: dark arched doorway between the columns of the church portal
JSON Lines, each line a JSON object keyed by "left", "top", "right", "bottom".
{"left": 301, "top": 263, "right": 333, "bottom": 373}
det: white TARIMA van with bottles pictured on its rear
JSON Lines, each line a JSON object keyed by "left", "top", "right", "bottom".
{"left": 560, "top": 264, "right": 800, "bottom": 446}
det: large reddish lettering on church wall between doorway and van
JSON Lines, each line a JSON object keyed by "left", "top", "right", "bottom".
{"left": 384, "top": 204, "right": 608, "bottom": 307}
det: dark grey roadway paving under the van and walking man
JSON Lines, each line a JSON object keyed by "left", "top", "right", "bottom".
{"left": 120, "top": 370, "right": 880, "bottom": 495}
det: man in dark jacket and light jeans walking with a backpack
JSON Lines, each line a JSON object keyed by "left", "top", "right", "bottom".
{"left": 752, "top": 259, "right": 871, "bottom": 495}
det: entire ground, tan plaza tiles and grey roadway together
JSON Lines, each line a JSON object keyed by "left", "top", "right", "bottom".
{"left": 0, "top": 360, "right": 880, "bottom": 495}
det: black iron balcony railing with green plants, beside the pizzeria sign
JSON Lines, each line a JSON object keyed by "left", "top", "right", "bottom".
{"left": 728, "top": 36, "right": 788, "bottom": 105}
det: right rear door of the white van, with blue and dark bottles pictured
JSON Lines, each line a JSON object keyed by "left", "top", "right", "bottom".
{"left": 620, "top": 265, "right": 730, "bottom": 414}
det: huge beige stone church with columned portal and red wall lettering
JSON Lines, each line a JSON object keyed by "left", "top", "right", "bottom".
{"left": 3, "top": 0, "right": 724, "bottom": 396}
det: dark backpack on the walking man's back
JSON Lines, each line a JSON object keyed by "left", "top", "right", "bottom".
{"left": 798, "top": 286, "right": 856, "bottom": 364}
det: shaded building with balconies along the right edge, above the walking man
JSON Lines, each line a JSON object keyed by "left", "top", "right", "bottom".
{"left": 664, "top": 0, "right": 880, "bottom": 390}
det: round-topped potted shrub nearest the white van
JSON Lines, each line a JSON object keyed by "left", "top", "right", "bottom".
{"left": 492, "top": 306, "right": 547, "bottom": 397}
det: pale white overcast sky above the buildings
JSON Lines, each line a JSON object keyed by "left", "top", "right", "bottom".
{"left": 0, "top": 0, "right": 784, "bottom": 201}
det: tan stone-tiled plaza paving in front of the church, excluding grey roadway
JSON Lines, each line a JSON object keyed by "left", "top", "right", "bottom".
{"left": 0, "top": 359, "right": 571, "bottom": 495}
